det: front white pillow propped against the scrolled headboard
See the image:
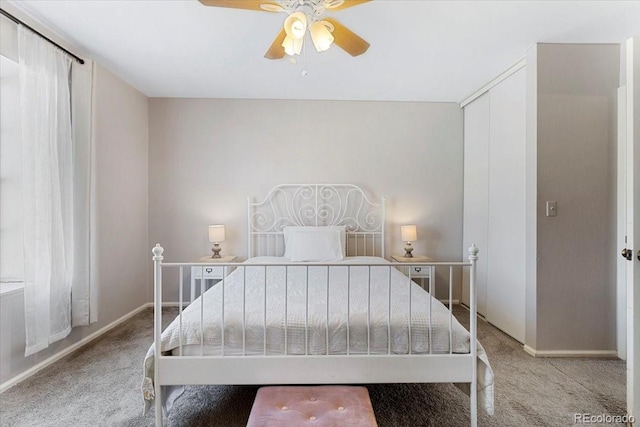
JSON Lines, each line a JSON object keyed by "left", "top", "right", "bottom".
{"left": 289, "top": 230, "right": 343, "bottom": 262}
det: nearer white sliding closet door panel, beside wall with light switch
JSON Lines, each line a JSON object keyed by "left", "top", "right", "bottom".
{"left": 487, "top": 69, "right": 526, "bottom": 342}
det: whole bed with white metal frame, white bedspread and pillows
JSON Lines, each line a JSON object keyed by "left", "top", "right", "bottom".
{"left": 142, "top": 184, "right": 493, "bottom": 426}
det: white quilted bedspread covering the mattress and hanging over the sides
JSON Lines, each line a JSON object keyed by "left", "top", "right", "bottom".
{"left": 143, "top": 257, "right": 493, "bottom": 414}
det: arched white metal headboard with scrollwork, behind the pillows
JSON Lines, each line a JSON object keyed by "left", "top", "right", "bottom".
{"left": 247, "top": 184, "right": 385, "bottom": 257}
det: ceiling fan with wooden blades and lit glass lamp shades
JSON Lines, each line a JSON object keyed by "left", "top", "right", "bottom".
{"left": 199, "top": 0, "right": 371, "bottom": 59}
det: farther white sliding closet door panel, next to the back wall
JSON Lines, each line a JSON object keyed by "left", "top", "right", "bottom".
{"left": 462, "top": 94, "right": 489, "bottom": 315}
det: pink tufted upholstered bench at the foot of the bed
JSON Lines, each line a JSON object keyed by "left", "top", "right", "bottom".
{"left": 247, "top": 386, "right": 378, "bottom": 427}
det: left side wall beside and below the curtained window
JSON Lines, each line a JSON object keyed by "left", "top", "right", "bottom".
{"left": 0, "top": 67, "right": 150, "bottom": 383}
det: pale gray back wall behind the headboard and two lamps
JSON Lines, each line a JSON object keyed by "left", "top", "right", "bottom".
{"left": 149, "top": 98, "right": 462, "bottom": 301}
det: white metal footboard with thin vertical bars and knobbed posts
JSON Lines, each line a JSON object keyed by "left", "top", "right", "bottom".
{"left": 153, "top": 245, "right": 478, "bottom": 426}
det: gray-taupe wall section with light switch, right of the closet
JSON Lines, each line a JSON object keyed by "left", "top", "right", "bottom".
{"left": 528, "top": 44, "right": 620, "bottom": 351}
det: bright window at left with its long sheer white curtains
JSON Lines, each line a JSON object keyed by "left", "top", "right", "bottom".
{"left": 0, "top": 18, "right": 97, "bottom": 356}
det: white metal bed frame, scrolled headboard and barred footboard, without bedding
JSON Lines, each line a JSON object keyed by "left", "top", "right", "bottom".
{"left": 152, "top": 184, "right": 478, "bottom": 426}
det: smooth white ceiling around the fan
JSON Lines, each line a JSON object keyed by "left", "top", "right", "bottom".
{"left": 6, "top": 0, "right": 640, "bottom": 102}
